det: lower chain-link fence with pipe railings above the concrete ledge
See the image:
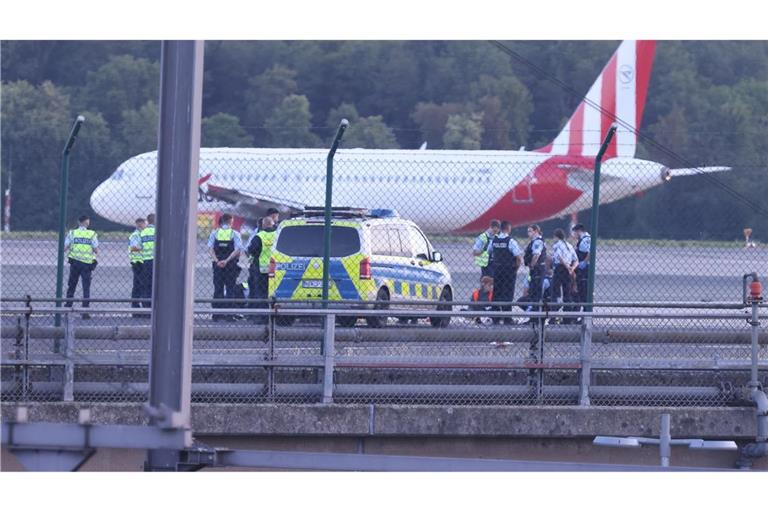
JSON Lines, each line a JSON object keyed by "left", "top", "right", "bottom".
{"left": 2, "top": 303, "right": 768, "bottom": 406}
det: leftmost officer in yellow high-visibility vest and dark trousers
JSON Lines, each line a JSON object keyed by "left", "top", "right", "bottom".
{"left": 64, "top": 215, "right": 99, "bottom": 319}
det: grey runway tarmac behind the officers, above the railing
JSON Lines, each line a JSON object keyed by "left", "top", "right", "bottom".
{"left": 0, "top": 236, "right": 768, "bottom": 302}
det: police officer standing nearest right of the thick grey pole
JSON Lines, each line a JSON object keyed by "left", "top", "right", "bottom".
{"left": 208, "top": 213, "right": 244, "bottom": 322}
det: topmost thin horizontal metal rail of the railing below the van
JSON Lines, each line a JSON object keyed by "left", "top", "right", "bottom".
{"left": 0, "top": 297, "right": 768, "bottom": 311}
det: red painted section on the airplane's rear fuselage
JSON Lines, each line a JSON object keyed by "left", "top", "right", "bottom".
{"left": 456, "top": 156, "right": 593, "bottom": 233}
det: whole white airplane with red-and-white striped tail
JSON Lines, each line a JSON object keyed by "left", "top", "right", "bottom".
{"left": 91, "top": 41, "right": 730, "bottom": 233}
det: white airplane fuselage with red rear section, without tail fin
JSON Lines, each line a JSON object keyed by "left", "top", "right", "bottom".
{"left": 91, "top": 148, "right": 665, "bottom": 233}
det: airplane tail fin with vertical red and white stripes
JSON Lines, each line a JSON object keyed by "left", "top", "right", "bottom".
{"left": 537, "top": 41, "right": 656, "bottom": 158}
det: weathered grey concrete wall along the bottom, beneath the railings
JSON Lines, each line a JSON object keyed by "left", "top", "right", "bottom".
{"left": 0, "top": 403, "right": 768, "bottom": 471}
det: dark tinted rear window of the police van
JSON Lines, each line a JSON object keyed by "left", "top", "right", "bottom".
{"left": 277, "top": 225, "right": 360, "bottom": 258}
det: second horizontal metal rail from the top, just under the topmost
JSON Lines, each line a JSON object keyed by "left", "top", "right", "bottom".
{"left": 0, "top": 303, "right": 768, "bottom": 320}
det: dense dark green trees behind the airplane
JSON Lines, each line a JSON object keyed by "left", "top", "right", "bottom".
{"left": 0, "top": 41, "right": 768, "bottom": 239}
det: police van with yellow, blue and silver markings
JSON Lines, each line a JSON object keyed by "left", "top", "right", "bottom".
{"left": 269, "top": 208, "right": 453, "bottom": 327}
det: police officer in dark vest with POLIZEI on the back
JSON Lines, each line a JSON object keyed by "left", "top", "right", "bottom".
{"left": 487, "top": 220, "right": 523, "bottom": 324}
